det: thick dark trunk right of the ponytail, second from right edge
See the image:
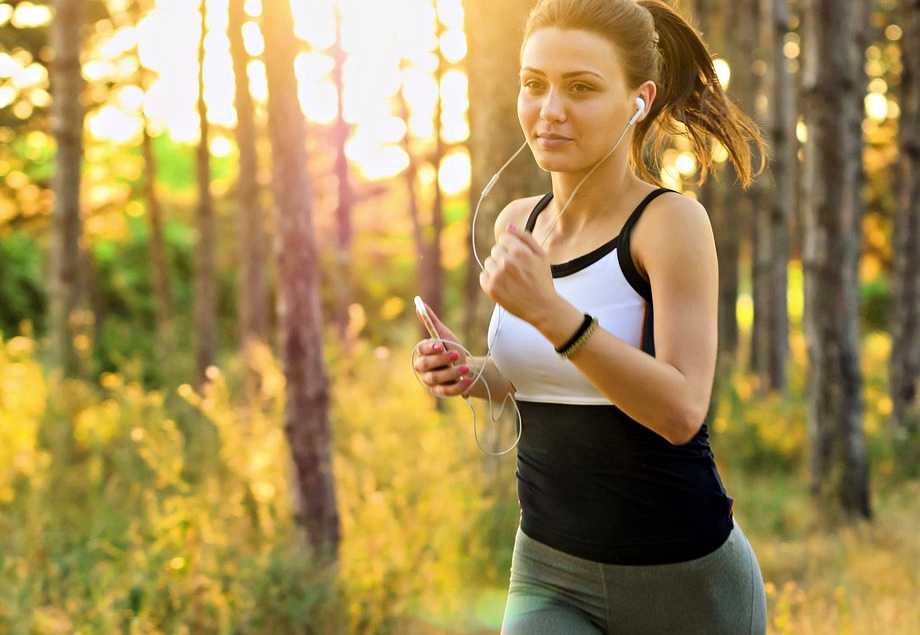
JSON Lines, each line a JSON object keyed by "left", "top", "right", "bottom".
{"left": 802, "top": 0, "right": 871, "bottom": 517}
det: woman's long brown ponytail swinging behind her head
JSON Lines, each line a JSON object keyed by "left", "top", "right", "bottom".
{"left": 631, "top": 0, "right": 766, "bottom": 187}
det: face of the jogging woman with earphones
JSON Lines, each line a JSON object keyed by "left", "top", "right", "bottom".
{"left": 518, "top": 27, "right": 636, "bottom": 172}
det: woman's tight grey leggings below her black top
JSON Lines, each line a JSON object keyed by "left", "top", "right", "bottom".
{"left": 501, "top": 523, "right": 767, "bottom": 635}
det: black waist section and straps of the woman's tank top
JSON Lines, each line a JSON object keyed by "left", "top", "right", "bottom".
{"left": 506, "top": 190, "right": 732, "bottom": 565}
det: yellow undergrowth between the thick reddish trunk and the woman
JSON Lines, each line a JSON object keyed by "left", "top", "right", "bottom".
{"left": 330, "top": 341, "right": 506, "bottom": 634}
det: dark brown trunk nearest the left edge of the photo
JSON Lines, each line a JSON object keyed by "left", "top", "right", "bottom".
{"left": 49, "top": 0, "right": 86, "bottom": 376}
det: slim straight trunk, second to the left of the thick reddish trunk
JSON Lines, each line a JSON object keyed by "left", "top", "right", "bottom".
{"left": 195, "top": 0, "right": 217, "bottom": 385}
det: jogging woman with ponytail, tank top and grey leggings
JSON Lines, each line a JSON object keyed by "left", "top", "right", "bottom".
{"left": 415, "top": 0, "right": 766, "bottom": 635}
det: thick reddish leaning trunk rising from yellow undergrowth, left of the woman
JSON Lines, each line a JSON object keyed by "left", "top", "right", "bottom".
{"left": 262, "top": 0, "right": 339, "bottom": 558}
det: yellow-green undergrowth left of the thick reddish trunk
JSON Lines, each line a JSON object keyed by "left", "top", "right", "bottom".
{"left": 0, "top": 337, "right": 342, "bottom": 633}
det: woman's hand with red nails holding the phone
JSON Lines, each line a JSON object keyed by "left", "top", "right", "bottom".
{"left": 412, "top": 307, "right": 473, "bottom": 397}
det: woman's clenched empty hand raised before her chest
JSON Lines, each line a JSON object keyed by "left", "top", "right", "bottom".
{"left": 479, "top": 225, "right": 559, "bottom": 323}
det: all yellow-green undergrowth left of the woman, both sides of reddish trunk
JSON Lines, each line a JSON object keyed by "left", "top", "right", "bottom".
{"left": 0, "top": 330, "right": 513, "bottom": 634}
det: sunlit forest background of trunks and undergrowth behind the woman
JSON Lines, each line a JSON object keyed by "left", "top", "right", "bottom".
{"left": 0, "top": 0, "right": 920, "bottom": 634}
